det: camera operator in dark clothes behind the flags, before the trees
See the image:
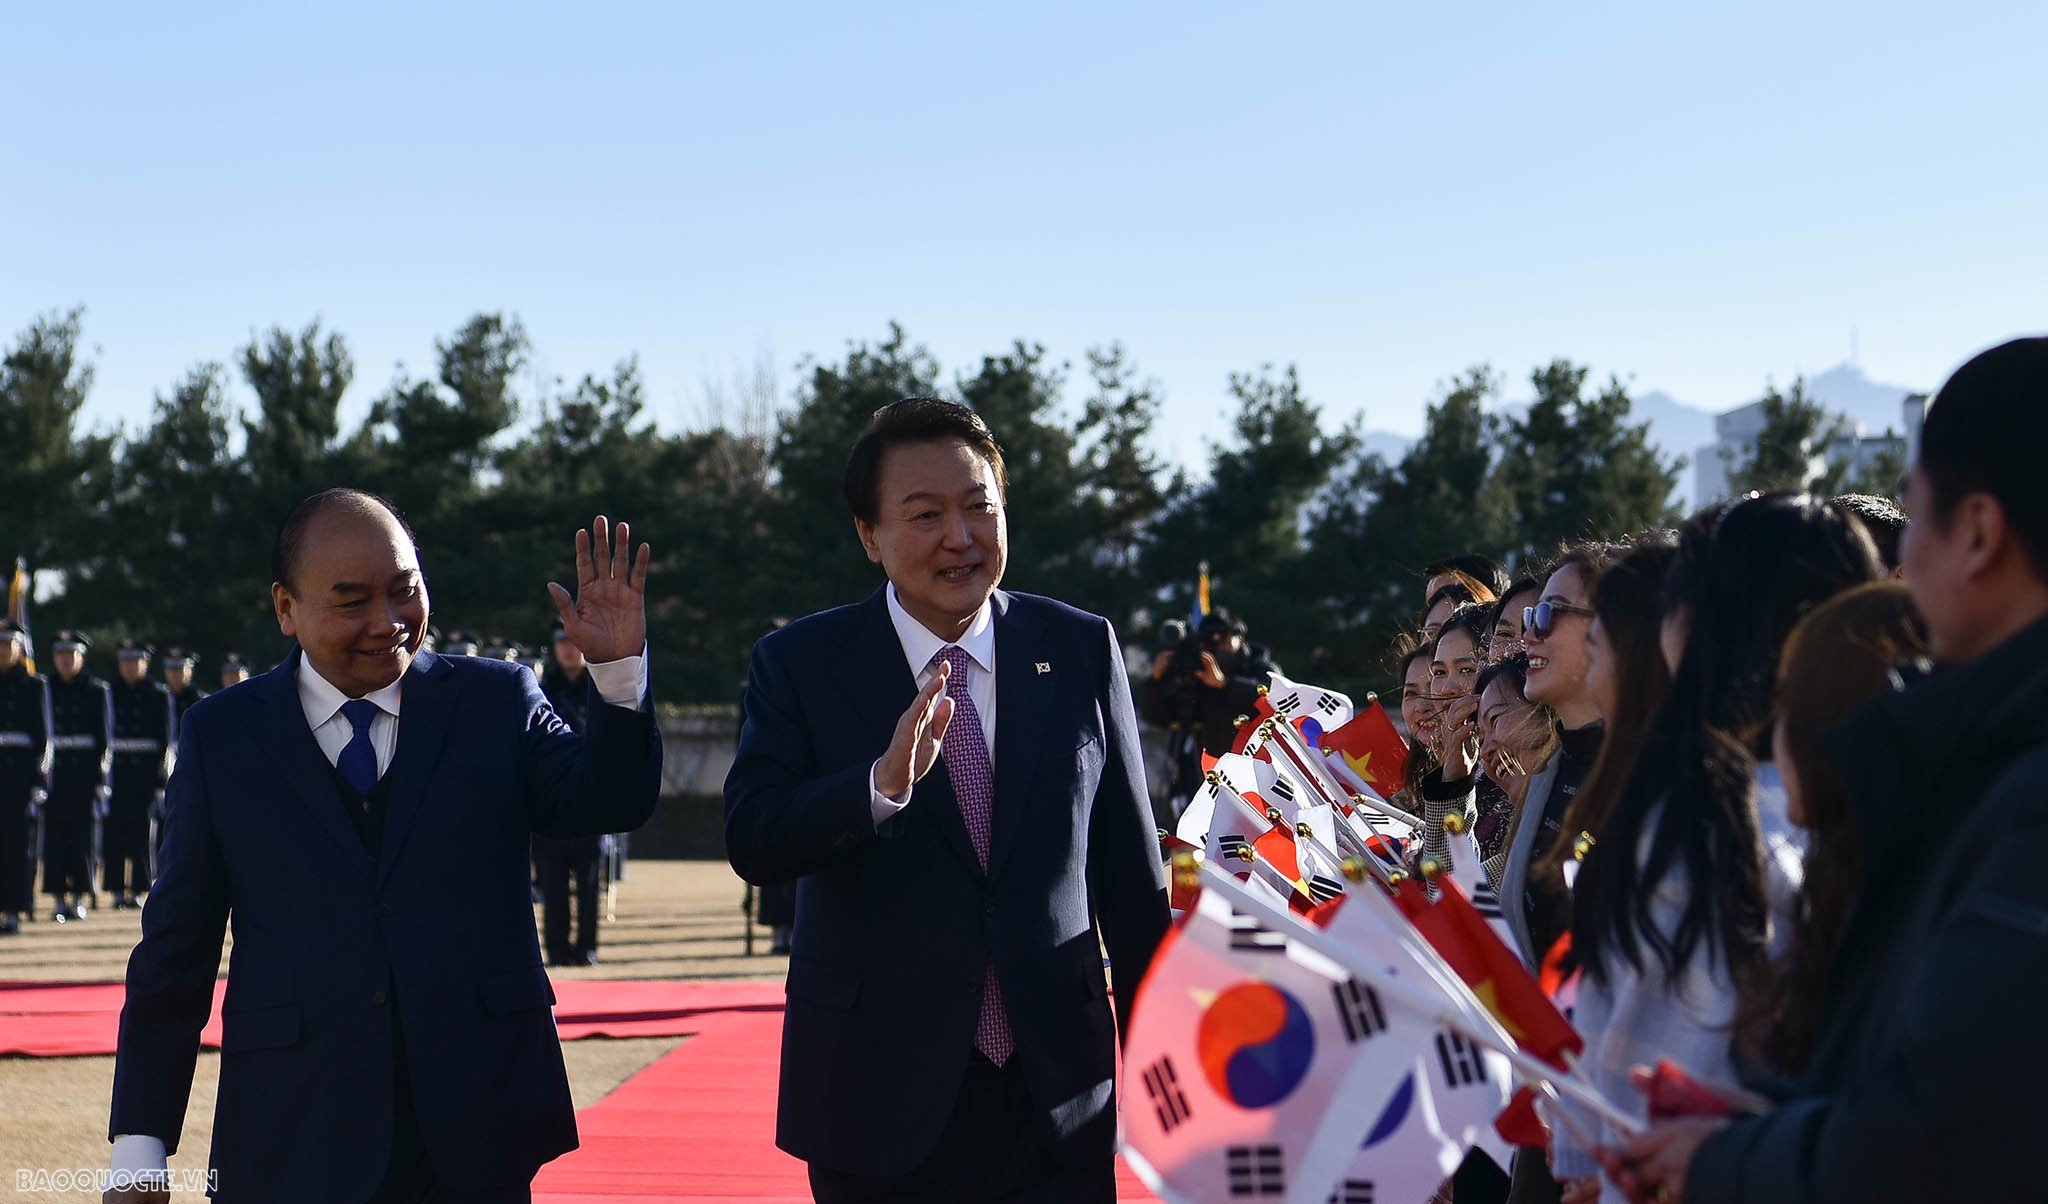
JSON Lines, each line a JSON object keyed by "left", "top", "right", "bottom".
{"left": 1139, "top": 606, "right": 1274, "bottom": 811}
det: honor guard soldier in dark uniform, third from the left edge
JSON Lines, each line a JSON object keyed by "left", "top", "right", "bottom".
{"left": 100, "top": 637, "right": 178, "bottom": 911}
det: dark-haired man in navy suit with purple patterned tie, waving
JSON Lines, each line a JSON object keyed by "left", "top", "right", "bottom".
{"left": 725, "top": 397, "right": 1167, "bottom": 1204}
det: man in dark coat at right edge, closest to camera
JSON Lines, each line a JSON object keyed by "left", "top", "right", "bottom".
{"left": 1606, "top": 338, "right": 2048, "bottom": 1204}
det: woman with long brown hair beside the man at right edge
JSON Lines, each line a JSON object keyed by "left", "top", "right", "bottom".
{"left": 1735, "top": 582, "right": 1927, "bottom": 1075}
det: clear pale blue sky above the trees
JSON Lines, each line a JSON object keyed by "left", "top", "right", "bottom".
{"left": 0, "top": 4, "right": 2048, "bottom": 468}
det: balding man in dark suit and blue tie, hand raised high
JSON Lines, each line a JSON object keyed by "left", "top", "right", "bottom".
{"left": 109, "top": 489, "right": 662, "bottom": 1204}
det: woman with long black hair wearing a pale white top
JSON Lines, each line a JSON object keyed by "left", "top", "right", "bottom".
{"left": 1550, "top": 493, "right": 1882, "bottom": 1204}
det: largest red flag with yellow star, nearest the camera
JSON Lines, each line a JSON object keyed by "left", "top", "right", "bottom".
{"left": 1395, "top": 874, "right": 1585, "bottom": 1069}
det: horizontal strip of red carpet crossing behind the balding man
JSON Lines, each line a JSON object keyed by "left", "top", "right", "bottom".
{"left": 0, "top": 979, "right": 782, "bottom": 1059}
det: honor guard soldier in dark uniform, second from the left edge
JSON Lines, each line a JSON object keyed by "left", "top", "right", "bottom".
{"left": 43, "top": 631, "right": 115, "bottom": 923}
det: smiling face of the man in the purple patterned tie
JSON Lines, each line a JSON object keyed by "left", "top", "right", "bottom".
{"left": 854, "top": 438, "right": 1010, "bottom": 641}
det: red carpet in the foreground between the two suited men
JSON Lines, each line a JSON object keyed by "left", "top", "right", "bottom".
{"left": 532, "top": 1007, "right": 1157, "bottom": 1204}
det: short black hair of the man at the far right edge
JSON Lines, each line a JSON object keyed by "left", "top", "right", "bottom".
{"left": 1919, "top": 338, "right": 2048, "bottom": 579}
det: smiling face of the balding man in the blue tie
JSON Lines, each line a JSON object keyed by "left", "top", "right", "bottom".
{"left": 270, "top": 506, "right": 426, "bottom": 698}
